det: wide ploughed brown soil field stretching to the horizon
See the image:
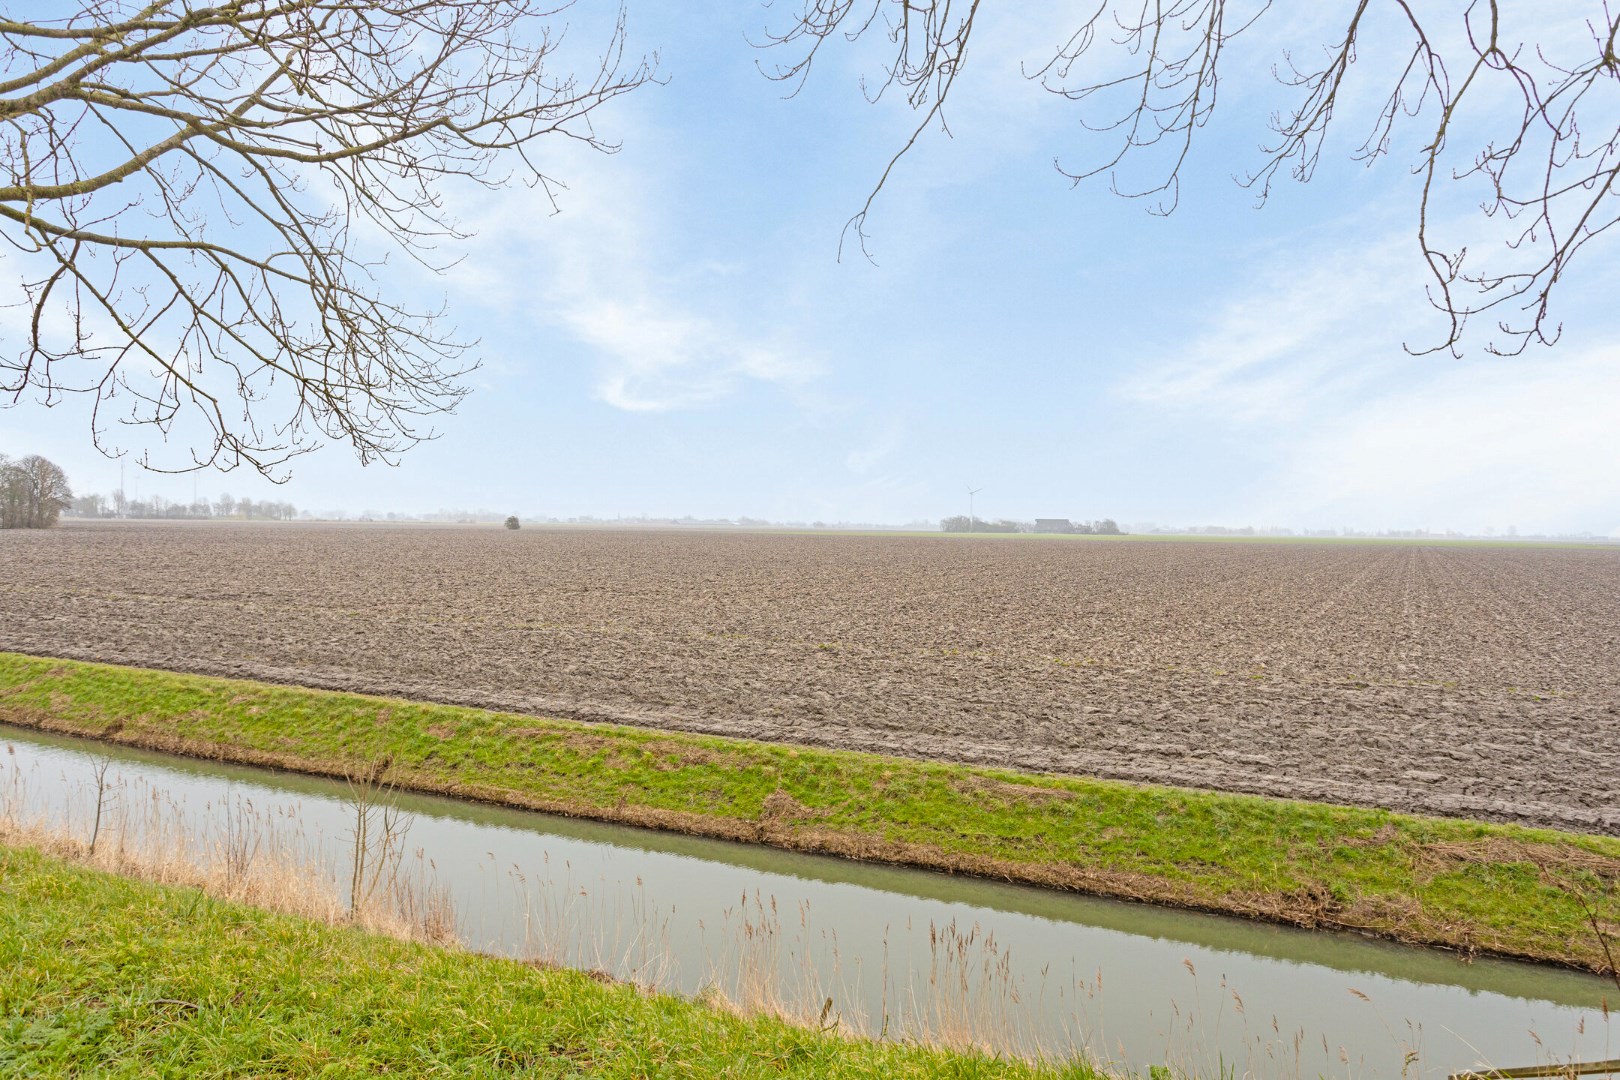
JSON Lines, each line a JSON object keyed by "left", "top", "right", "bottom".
{"left": 0, "top": 523, "right": 1620, "bottom": 836}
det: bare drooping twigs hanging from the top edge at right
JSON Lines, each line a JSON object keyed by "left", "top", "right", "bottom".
{"left": 765, "top": 0, "right": 1620, "bottom": 351}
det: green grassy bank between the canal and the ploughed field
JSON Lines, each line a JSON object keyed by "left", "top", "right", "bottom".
{"left": 0, "top": 653, "right": 1620, "bottom": 970}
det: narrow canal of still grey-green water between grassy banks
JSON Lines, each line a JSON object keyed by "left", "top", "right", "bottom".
{"left": 0, "top": 729, "right": 1620, "bottom": 1077}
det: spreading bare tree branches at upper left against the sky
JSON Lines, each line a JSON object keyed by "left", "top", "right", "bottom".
{"left": 0, "top": 0, "right": 650, "bottom": 478}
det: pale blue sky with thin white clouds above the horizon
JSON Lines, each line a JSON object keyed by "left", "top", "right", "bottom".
{"left": 0, "top": 0, "right": 1620, "bottom": 533}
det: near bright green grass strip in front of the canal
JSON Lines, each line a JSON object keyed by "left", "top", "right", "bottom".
{"left": 0, "top": 848, "right": 1095, "bottom": 1080}
